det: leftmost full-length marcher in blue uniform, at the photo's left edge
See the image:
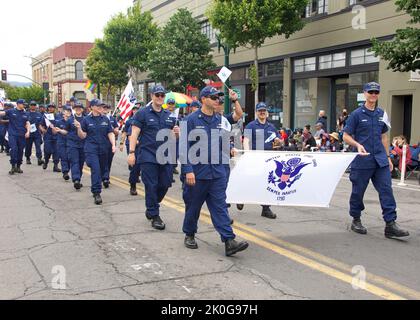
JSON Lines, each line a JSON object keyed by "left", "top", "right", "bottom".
{"left": 0, "top": 99, "right": 31, "bottom": 175}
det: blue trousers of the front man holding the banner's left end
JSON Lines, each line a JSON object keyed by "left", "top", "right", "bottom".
{"left": 182, "top": 177, "right": 235, "bottom": 242}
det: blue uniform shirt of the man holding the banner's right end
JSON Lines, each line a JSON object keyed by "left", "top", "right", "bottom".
{"left": 344, "top": 106, "right": 389, "bottom": 169}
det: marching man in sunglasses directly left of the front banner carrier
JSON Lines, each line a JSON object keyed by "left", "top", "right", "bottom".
{"left": 127, "top": 85, "right": 179, "bottom": 230}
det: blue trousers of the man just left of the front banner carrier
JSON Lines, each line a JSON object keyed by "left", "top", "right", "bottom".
{"left": 141, "top": 163, "right": 173, "bottom": 217}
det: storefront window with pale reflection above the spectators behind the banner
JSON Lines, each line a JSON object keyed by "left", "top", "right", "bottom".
{"left": 294, "top": 78, "right": 331, "bottom": 128}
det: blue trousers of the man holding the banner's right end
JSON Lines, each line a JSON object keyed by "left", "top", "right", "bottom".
{"left": 350, "top": 166, "right": 397, "bottom": 222}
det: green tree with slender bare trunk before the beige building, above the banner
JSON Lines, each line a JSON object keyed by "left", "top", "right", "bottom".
{"left": 207, "top": 0, "right": 308, "bottom": 102}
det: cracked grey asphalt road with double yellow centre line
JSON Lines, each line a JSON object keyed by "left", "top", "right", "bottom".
{"left": 0, "top": 153, "right": 420, "bottom": 300}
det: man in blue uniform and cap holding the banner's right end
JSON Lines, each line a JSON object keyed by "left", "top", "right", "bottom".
{"left": 343, "top": 82, "right": 409, "bottom": 238}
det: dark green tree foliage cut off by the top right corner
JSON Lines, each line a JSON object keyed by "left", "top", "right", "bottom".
{"left": 372, "top": 0, "right": 420, "bottom": 72}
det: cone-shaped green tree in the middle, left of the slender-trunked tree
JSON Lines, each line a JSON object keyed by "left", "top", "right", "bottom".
{"left": 149, "top": 9, "right": 216, "bottom": 92}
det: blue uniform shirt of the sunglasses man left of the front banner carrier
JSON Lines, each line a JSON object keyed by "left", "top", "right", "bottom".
{"left": 132, "top": 106, "right": 175, "bottom": 163}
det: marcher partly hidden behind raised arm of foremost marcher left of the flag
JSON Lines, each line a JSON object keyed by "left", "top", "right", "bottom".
{"left": 66, "top": 102, "right": 85, "bottom": 190}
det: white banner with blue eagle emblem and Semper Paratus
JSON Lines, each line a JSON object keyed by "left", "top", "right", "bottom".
{"left": 226, "top": 151, "right": 357, "bottom": 207}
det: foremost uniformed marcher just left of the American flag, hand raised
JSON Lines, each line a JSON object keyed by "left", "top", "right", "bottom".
{"left": 74, "top": 99, "right": 116, "bottom": 205}
